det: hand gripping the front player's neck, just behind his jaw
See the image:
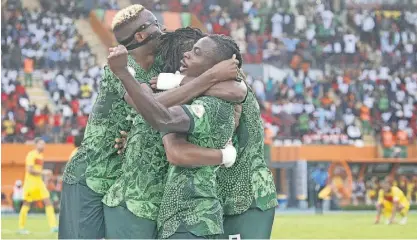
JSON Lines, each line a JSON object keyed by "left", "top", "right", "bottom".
{"left": 210, "top": 54, "right": 239, "bottom": 82}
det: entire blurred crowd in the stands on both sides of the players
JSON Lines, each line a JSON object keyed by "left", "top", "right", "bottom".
{"left": 1, "top": 0, "right": 417, "bottom": 154}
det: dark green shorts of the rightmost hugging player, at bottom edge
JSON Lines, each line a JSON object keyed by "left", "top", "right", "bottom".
{"left": 221, "top": 208, "right": 275, "bottom": 239}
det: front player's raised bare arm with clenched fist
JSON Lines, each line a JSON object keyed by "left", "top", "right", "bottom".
{"left": 108, "top": 46, "right": 195, "bottom": 133}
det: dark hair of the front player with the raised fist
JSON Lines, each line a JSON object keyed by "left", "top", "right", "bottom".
{"left": 208, "top": 34, "right": 242, "bottom": 68}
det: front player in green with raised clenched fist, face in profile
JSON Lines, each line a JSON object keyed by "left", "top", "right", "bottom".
{"left": 109, "top": 37, "right": 240, "bottom": 238}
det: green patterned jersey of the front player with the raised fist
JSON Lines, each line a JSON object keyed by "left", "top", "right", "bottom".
{"left": 158, "top": 97, "right": 234, "bottom": 238}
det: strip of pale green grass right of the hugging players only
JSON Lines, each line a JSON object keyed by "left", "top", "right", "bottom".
{"left": 272, "top": 212, "right": 417, "bottom": 239}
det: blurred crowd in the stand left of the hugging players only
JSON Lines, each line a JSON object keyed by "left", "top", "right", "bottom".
{"left": 2, "top": 1, "right": 117, "bottom": 143}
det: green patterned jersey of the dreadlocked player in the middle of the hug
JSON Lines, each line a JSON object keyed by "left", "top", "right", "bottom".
{"left": 103, "top": 58, "right": 168, "bottom": 220}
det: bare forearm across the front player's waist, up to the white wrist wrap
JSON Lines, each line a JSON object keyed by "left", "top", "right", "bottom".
{"left": 162, "top": 133, "right": 223, "bottom": 167}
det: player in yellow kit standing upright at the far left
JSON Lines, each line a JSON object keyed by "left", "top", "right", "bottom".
{"left": 18, "top": 138, "right": 58, "bottom": 234}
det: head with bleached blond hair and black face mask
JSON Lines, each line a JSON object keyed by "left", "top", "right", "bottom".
{"left": 112, "top": 4, "right": 161, "bottom": 47}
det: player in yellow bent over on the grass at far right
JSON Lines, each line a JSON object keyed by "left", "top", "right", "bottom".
{"left": 375, "top": 180, "right": 410, "bottom": 224}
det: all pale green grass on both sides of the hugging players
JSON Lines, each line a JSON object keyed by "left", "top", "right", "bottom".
{"left": 1, "top": 212, "right": 417, "bottom": 239}
